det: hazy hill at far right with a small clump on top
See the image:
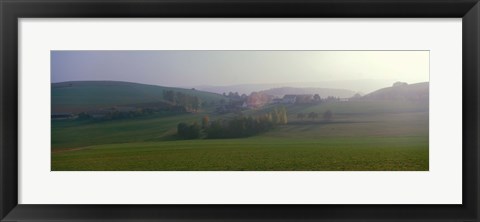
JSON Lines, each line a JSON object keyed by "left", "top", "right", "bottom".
{"left": 362, "top": 82, "right": 429, "bottom": 102}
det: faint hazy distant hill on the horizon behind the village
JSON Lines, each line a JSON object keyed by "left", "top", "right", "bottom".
{"left": 261, "top": 87, "right": 355, "bottom": 98}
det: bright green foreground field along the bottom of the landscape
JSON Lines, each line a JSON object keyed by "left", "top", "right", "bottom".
{"left": 52, "top": 137, "right": 428, "bottom": 171}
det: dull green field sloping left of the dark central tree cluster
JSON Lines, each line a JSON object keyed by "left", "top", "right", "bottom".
{"left": 52, "top": 113, "right": 203, "bottom": 150}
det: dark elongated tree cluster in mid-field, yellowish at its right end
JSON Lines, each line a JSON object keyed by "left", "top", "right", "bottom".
{"left": 177, "top": 107, "right": 288, "bottom": 139}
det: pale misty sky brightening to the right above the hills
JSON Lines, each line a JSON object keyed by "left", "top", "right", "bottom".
{"left": 51, "top": 50, "right": 429, "bottom": 86}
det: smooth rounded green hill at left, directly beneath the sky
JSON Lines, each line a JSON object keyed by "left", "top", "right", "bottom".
{"left": 51, "top": 81, "right": 223, "bottom": 113}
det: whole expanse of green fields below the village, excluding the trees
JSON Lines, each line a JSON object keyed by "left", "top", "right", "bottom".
{"left": 52, "top": 99, "right": 429, "bottom": 171}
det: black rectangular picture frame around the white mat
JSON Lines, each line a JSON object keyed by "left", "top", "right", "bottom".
{"left": 0, "top": 0, "right": 480, "bottom": 222}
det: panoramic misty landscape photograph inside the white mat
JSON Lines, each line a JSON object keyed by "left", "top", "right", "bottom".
{"left": 50, "top": 50, "right": 429, "bottom": 171}
